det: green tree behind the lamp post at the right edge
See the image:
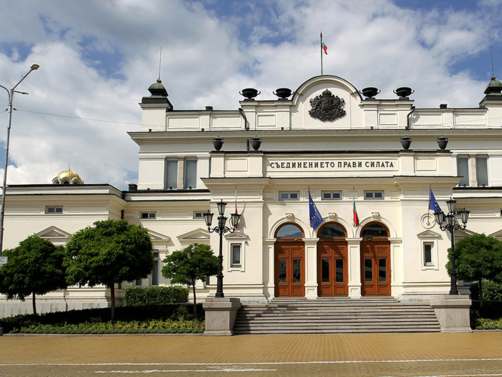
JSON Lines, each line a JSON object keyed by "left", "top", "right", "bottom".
{"left": 446, "top": 234, "right": 502, "bottom": 306}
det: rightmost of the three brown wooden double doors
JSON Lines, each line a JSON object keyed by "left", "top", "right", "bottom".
{"left": 361, "top": 237, "right": 391, "bottom": 296}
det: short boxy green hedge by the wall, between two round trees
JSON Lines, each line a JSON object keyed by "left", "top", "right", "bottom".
{"left": 124, "top": 286, "right": 188, "bottom": 306}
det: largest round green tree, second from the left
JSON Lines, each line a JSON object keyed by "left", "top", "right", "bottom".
{"left": 66, "top": 220, "right": 153, "bottom": 319}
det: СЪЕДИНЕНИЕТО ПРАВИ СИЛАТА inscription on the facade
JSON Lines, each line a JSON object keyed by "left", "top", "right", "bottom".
{"left": 268, "top": 159, "right": 398, "bottom": 171}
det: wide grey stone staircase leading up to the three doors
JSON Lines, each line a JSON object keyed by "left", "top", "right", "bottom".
{"left": 234, "top": 297, "right": 441, "bottom": 334}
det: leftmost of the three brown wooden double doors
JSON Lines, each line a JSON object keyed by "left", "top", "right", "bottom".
{"left": 275, "top": 241, "right": 305, "bottom": 297}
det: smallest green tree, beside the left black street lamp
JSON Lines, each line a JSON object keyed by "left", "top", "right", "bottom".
{"left": 162, "top": 243, "right": 218, "bottom": 317}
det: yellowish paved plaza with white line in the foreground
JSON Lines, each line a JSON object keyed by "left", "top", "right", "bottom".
{"left": 0, "top": 332, "right": 502, "bottom": 377}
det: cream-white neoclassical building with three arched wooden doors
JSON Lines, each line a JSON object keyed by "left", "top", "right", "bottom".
{"left": 0, "top": 75, "right": 502, "bottom": 315}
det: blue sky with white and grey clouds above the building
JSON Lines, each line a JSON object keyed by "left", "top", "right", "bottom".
{"left": 0, "top": 0, "right": 502, "bottom": 190}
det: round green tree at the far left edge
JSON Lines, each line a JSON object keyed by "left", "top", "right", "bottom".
{"left": 0, "top": 235, "right": 67, "bottom": 314}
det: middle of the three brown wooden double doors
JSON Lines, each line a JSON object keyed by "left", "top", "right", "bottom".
{"left": 317, "top": 239, "right": 348, "bottom": 297}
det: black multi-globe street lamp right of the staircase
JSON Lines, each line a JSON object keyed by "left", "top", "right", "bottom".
{"left": 434, "top": 199, "right": 471, "bottom": 295}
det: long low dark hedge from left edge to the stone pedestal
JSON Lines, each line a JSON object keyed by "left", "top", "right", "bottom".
{"left": 0, "top": 304, "right": 204, "bottom": 333}
